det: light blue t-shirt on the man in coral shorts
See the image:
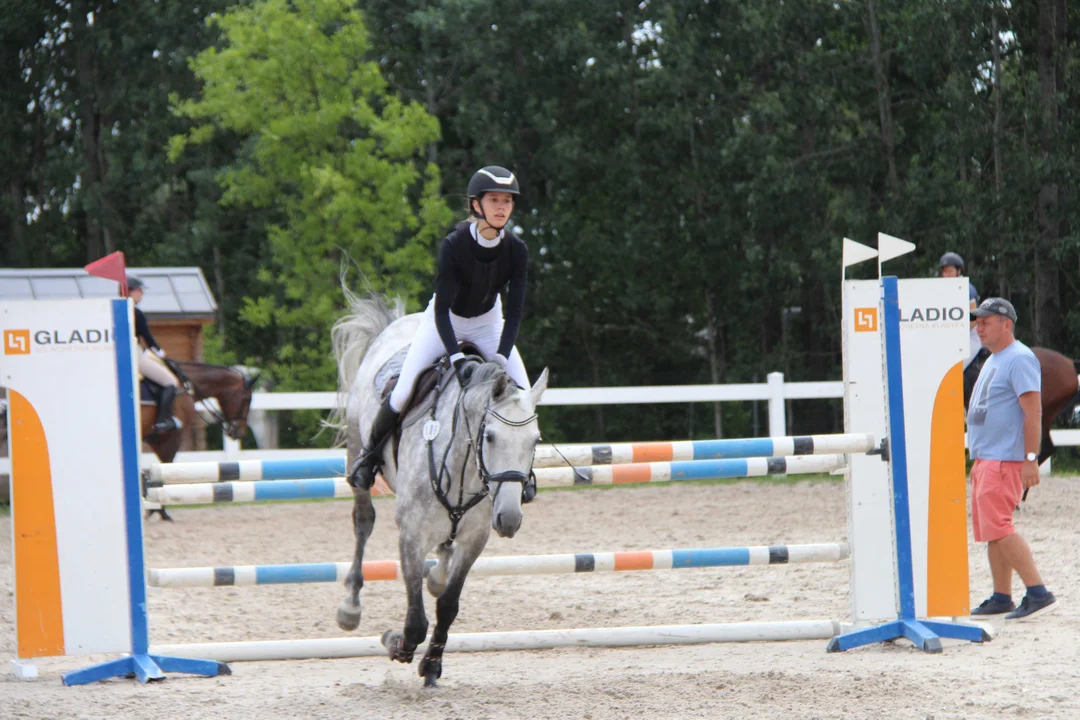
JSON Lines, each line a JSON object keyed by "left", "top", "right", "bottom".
{"left": 968, "top": 340, "right": 1042, "bottom": 461}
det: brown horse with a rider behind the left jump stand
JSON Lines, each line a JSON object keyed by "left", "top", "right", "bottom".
{"left": 140, "top": 363, "right": 259, "bottom": 520}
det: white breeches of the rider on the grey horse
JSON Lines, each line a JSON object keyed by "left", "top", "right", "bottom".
{"left": 390, "top": 297, "right": 531, "bottom": 412}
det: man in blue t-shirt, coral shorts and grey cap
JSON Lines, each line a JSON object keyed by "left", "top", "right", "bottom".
{"left": 968, "top": 298, "right": 1057, "bottom": 620}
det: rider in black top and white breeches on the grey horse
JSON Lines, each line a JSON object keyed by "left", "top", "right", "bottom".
{"left": 349, "top": 165, "right": 529, "bottom": 488}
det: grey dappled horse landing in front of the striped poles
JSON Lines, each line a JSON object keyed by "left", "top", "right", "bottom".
{"left": 332, "top": 291, "right": 548, "bottom": 687}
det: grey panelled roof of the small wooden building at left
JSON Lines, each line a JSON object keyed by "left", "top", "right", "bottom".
{"left": 0, "top": 268, "right": 217, "bottom": 320}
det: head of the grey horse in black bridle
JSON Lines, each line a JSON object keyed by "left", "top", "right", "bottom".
{"left": 466, "top": 364, "right": 548, "bottom": 538}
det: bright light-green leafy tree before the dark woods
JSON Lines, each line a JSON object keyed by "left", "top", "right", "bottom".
{"left": 170, "top": 0, "right": 451, "bottom": 440}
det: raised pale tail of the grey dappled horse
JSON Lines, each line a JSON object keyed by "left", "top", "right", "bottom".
{"left": 325, "top": 282, "right": 405, "bottom": 445}
